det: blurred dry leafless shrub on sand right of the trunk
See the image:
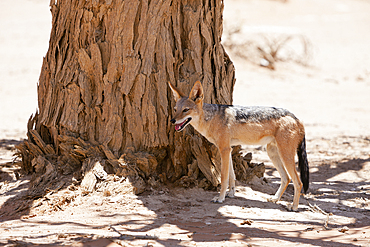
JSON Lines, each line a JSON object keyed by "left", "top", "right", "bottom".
{"left": 223, "top": 24, "right": 313, "bottom": 69}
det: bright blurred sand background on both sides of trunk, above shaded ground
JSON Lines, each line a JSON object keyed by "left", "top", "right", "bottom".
{"left": 0, "top": 0, "right": 370, "bottom": 139}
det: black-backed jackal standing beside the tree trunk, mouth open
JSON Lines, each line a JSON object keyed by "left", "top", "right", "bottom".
{"left": 169, "top": 81, "right": 309, "bottom": 211}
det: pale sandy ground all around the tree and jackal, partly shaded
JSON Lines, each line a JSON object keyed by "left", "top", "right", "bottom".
{"left": 0, "top": 0, "right": 370, "bottom": 246}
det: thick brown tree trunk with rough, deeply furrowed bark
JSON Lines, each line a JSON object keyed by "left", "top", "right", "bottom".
{"left": 18, "top": 0, "right": 254, "bottom": 193}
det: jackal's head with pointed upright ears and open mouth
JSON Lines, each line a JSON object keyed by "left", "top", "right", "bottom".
{"left": 168, "top": 81, "right": 203, "bottom": 131}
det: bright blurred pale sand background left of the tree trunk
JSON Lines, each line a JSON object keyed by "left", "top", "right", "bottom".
{"left": 0, "top": 0, "right": 51, "bottom": 139}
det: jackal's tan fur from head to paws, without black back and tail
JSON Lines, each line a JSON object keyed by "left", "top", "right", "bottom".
{"left": 169, "top": 81, "right": 305, "bottom": 210}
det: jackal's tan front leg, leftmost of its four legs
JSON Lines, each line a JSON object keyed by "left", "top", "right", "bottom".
{"left": 212, "top": 147, "right": 231, "bottom": 203}
